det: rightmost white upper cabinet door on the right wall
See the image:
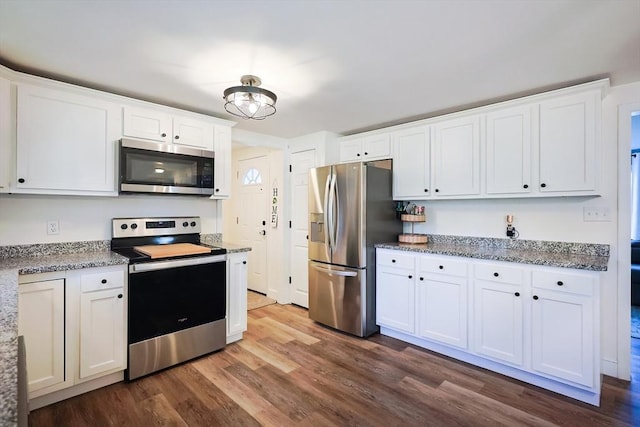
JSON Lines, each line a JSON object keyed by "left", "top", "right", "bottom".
{"left": 539, "top": 91, "right": 600, "bottom": 193}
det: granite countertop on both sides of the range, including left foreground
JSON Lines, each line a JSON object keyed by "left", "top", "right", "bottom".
{"left": 0, "top": 234, "right": 251, "bottom": 426}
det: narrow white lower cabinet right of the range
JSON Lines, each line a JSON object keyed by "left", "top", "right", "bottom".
{"left": 227, "top": 252, "right": 248, "bottom": 344}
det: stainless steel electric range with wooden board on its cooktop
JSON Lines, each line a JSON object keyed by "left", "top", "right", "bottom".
{"left": 111, "top": 217, "right": 227, "bottom": 380}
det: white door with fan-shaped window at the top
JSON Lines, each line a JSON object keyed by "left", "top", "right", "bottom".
{"left": 236, "top": 156, "right": 269, "bottom": 295}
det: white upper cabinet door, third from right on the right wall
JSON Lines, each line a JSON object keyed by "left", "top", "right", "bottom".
{"left": 432, "top": 116, "right": 480, "bottom": 197}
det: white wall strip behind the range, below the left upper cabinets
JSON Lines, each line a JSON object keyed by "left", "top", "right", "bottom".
{"left": 0, "top": 194, "right": 221, "bottom": 246}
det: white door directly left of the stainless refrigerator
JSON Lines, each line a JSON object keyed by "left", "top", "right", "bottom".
{"left": 291, "top": 150, "right": 316, "bottom": 308}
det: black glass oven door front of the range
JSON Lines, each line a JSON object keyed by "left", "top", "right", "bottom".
{"left": 129, "top": 262, "right": 226, "bottom": 344}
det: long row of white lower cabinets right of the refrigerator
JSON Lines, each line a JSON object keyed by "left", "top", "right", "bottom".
{"left": 376, "top": 248, "right": 600, "bottom": 406}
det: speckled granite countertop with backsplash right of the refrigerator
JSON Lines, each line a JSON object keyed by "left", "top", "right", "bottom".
{"left": 375, "top": 235, "right": 609, "bottom": 271}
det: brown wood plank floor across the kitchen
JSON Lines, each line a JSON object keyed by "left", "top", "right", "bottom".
{"left": 29, "top": 304, "right": 640, "bottom": 427}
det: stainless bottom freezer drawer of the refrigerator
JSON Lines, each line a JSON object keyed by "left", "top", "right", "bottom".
{"left": 309, "top": 261, "right": 375, "bottom": 337}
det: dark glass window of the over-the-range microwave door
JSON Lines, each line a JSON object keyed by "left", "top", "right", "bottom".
{"left": 123, "top": 149, "right": 208, "bottom": 187}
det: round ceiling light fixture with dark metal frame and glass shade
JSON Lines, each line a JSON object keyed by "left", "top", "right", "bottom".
{"left": 224, "top": 75, "right": 278, "bottom": 120}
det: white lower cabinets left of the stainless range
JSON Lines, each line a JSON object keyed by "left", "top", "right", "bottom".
{"left": 18, "top": 265, "right": 127, "bottom": 409}
